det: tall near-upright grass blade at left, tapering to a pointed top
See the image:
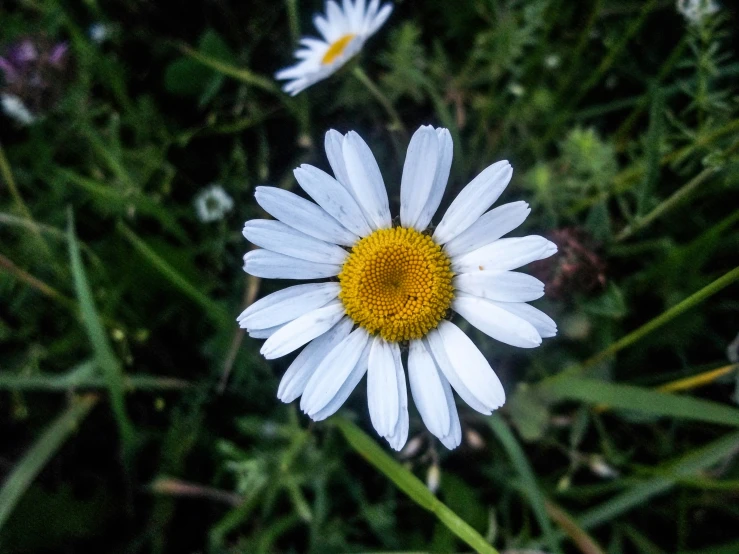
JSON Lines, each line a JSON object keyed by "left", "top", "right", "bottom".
{"left": 67, "top": 210, "right": 134, "bottom": 455}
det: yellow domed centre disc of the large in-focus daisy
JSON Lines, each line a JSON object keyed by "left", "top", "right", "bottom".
{"left": 339, "top": 227, "right": 453, "bottom": 342}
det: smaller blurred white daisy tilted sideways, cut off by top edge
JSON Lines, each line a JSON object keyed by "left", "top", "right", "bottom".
{"left": 275, "top": 0, "right": 393, "bottom": 96}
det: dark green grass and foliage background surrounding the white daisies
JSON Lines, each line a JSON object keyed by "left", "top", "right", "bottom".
{"left": 0, "top": 0, "right": 739, "bottom": 554}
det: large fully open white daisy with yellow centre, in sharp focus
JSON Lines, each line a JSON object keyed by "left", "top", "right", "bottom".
{"left": 238, "top": 126, "right": 557, "bottom": 450}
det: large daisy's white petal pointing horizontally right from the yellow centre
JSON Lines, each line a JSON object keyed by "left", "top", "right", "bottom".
{"left": 453, "top": 269, "right": 544, "bottom": 302}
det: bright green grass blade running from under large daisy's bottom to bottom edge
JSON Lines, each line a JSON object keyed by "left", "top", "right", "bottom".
{"left": 335, "top": 417, "right": 498, "bottom": 554}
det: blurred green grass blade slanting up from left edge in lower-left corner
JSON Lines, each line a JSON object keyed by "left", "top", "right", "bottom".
{"left": 0, "top": 394, "right": 98, "bottom": 530}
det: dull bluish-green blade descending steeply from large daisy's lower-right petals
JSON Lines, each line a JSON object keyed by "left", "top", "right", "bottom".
{"left": 488, "top": 414, "right": 561, "bottom": 552}
